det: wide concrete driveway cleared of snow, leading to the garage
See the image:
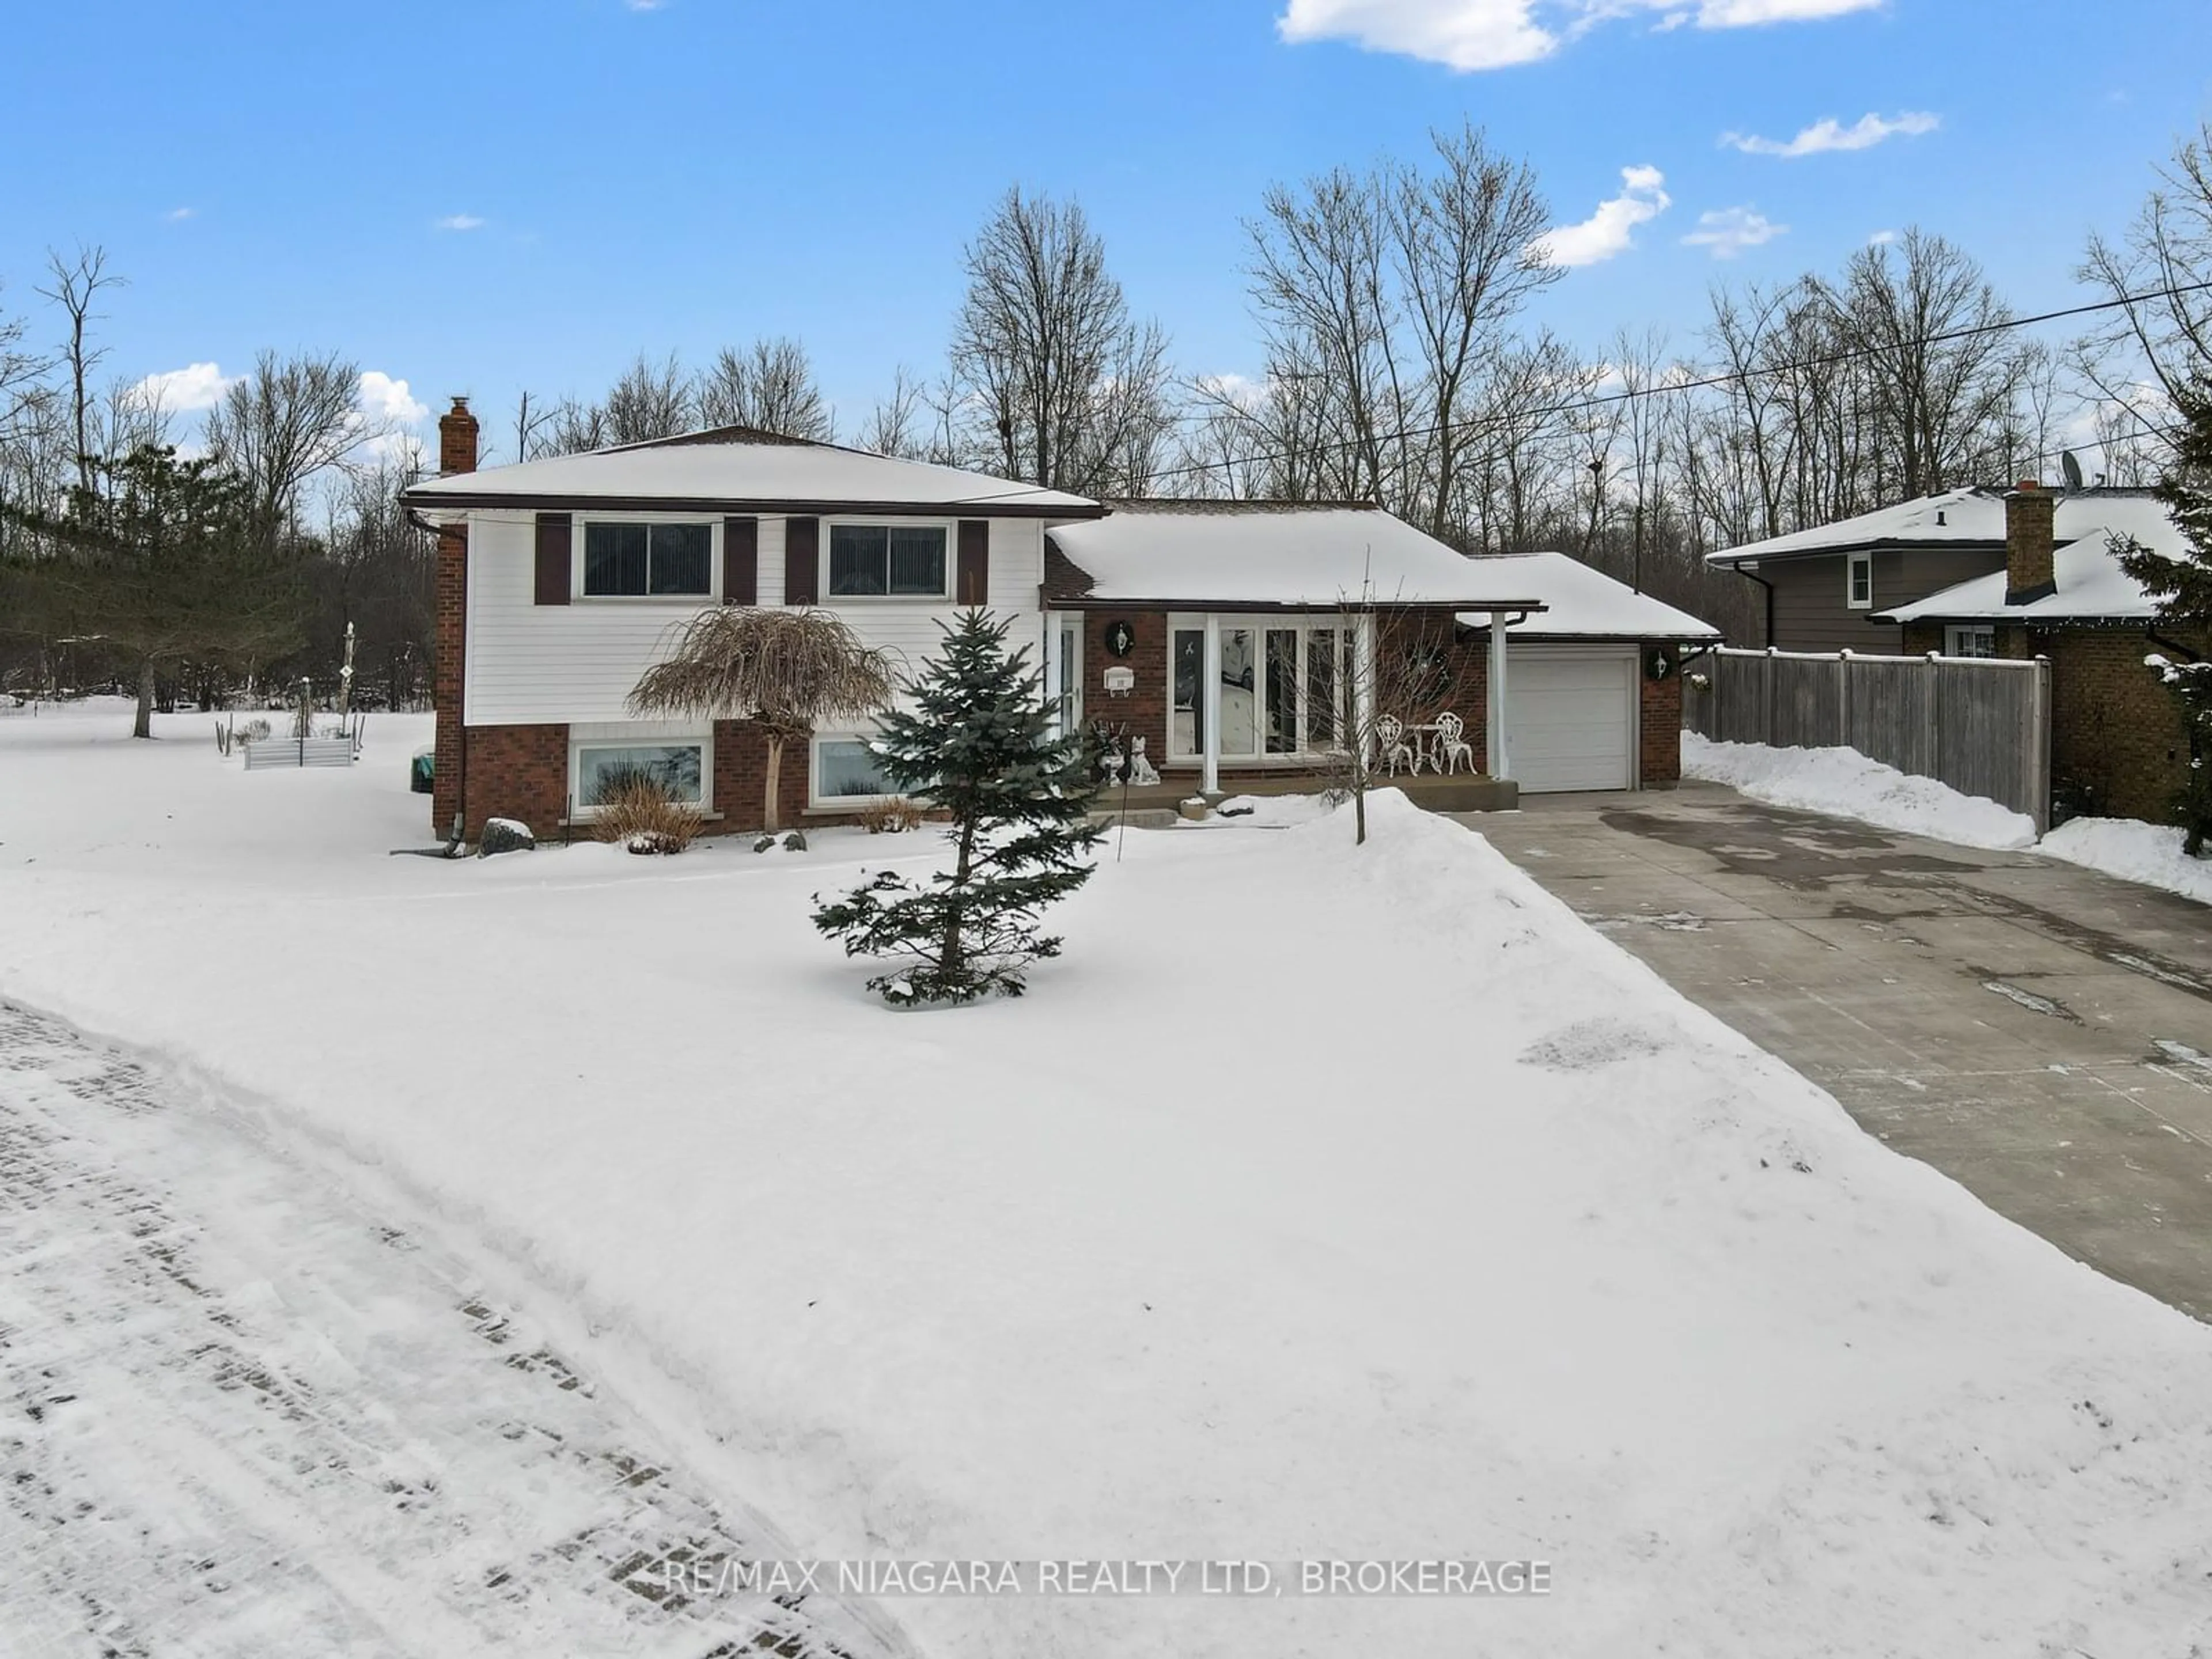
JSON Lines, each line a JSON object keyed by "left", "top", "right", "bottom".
{"left": 1464, "top": 783, "right": 2212, "bottom": 1319}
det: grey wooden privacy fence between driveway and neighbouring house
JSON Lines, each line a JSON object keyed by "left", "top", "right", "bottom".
{"left": 1681, "top": 646, "right": 2051, "bottom": 834}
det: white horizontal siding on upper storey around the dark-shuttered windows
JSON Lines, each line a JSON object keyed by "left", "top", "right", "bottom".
{"left": 463, "top": 513, "right": 1044, "bottom": 726}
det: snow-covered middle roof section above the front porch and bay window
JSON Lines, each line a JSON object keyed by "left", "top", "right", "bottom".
{"left": 1051, "top": 502, "right": 1541, "bottom": 611}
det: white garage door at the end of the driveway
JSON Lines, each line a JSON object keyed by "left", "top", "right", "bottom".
{"left": 1506, "top": 646, "right": 1641, "bottom": 794}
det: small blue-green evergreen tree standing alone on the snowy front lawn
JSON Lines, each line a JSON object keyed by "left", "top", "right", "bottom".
{"left": 814, "top": 611, "right": 1101, "bottom": 1006}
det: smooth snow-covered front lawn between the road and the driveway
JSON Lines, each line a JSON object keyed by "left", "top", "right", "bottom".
{"left": 0, "top": 714, "right": 2212, "bottom": 1659}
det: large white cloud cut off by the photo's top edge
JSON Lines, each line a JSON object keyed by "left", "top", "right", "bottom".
{"left": 1274, "top": 0, "right": 1883, "bottom": 71}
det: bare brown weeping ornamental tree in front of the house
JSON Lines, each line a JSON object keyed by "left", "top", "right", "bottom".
{"left": 630, "top": 604, "right": 892, "bottom": 830}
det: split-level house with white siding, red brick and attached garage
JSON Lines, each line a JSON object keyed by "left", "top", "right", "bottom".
{"left": 403, "top": 400, "right": 1712, "bottom": 836}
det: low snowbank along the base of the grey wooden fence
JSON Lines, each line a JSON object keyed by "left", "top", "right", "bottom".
{"left": 1681, "top": 732, "right": 2035, "bottom": 850}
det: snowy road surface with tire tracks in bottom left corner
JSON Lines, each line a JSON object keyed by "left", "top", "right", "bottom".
{"left": 0, "top": 1002, "right": 907, "bottom": 1659}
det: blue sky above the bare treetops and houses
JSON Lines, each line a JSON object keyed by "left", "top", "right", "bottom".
{"left": 0, "top": 0, "right": 2212, "bottom": 462}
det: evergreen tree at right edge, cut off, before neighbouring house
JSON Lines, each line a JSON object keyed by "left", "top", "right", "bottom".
{"left": 2112, "top": 378, "right": 2212, "bottom": 858}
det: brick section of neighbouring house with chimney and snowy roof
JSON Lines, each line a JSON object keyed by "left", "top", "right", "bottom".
{"left": 1878, "top": 482, "right": 2212, "bottom": 823}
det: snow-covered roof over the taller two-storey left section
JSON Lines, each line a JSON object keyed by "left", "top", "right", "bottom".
{"left": 400, "top": 427, "right": 1101, "bottom": 518}
